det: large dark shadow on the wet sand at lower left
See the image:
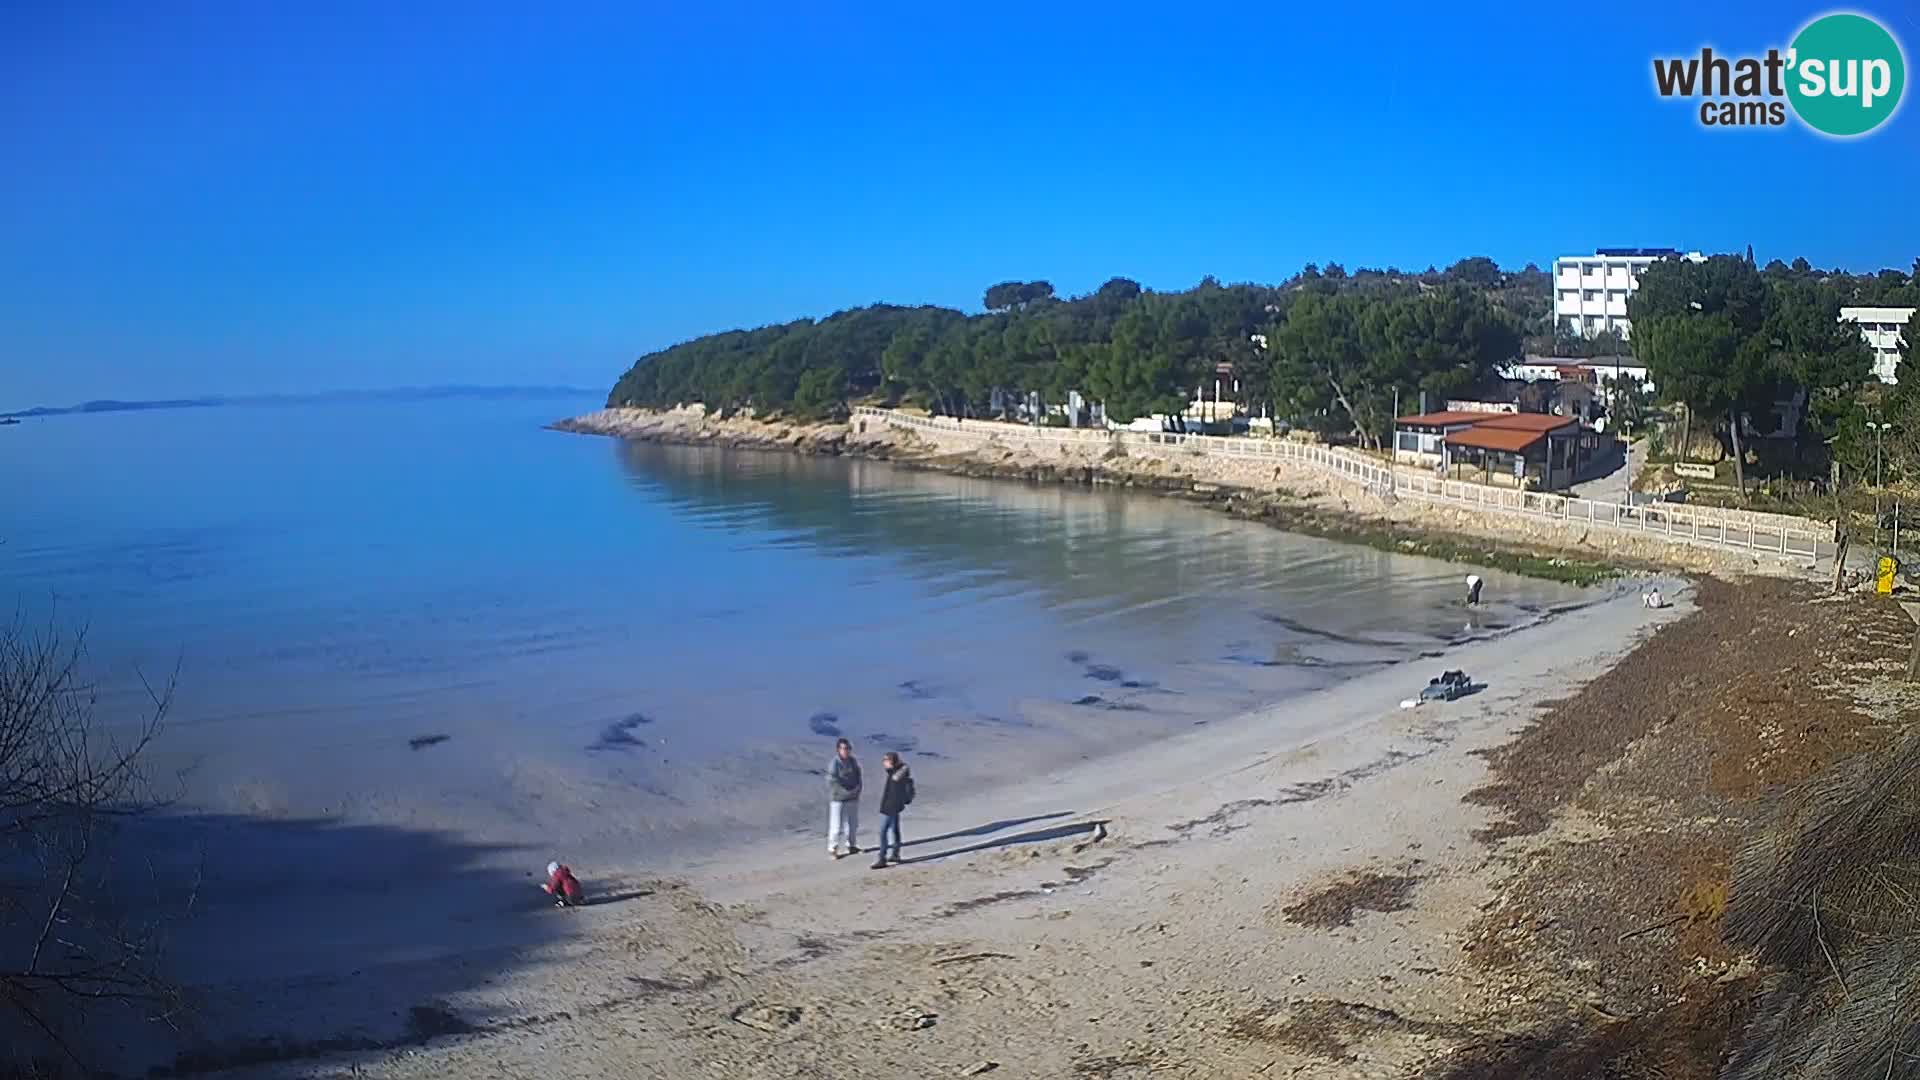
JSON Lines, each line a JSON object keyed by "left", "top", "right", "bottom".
{"left": 90, "top": 815, "right": 564, "bottom": 1076}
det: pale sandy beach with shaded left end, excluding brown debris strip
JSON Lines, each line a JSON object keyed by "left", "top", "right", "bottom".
{"left": 127, "top": 568, "right": 1692, "bottom": 1078}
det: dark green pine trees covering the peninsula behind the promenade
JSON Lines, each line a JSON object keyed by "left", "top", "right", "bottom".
{"left": 609, "top": 256, "right": 1920, "bottom": 442}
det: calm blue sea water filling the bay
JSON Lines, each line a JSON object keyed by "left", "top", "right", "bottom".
{"left": 0, "top": 398, "right": 1580, "bottom": 851}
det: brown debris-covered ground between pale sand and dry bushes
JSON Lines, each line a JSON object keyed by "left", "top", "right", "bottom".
{"left": 1430, "top": 580, "right": 1914, "bottom": 1080}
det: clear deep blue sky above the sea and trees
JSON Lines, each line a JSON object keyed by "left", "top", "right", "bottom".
{"left": 0, "top": 0, "right": 1920, "bottom": 405}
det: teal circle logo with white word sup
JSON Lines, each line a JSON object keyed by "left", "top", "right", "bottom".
{"left": 1788, "top": 13, "right": 1907, "bottom": 138}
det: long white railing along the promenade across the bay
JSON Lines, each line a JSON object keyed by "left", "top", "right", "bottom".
{"left": 854, "top": 405, "right": 1832, "bottom": 559}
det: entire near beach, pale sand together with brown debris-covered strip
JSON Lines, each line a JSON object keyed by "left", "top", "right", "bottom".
{"left": 116, "top": 418, "right": 1910, "bottom": 1080}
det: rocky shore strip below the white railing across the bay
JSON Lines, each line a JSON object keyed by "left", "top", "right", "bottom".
{"left": 547, "top": 405, "right": 1778, "bottom": 584}
